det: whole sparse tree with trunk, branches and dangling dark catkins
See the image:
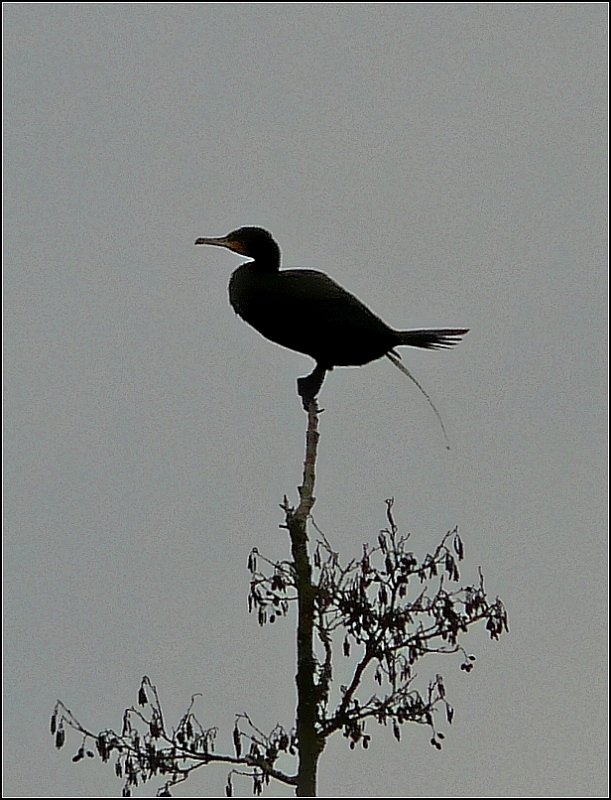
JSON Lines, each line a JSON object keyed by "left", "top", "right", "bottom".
{"left": 51, "top": 401, "right": 508, "bottom": 797}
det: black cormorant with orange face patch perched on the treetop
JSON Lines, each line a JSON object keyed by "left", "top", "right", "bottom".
{"left": 195, "top": 226, "right": 468, "bottom": 418}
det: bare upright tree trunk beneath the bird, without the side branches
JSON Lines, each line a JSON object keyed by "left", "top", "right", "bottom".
{"left": 286, "top": 401, "right": 324, "bottom": 797}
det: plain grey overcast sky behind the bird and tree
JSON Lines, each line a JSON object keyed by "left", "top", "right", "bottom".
{"left": 3, "top": 3, "right": 607, "bottom": 797}
